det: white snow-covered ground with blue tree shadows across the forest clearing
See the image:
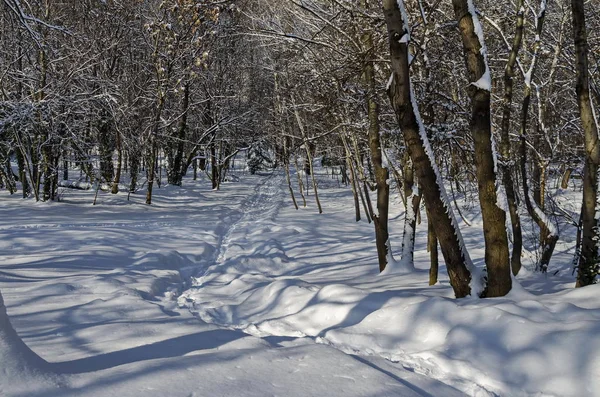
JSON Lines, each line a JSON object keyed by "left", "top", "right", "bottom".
{"left": 0, "top": 167, "right": 600, "bottom": 397}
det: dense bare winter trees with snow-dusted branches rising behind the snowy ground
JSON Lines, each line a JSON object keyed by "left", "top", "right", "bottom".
{"left": 0, "top": 0, "right": 600, "bottom": 297}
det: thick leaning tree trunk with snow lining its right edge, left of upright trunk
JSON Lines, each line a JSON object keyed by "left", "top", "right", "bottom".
{"left": 383, "top": 0, "right": 471, "bottom": 298}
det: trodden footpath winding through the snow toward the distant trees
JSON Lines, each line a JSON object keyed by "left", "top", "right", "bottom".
{"left": 178, "top": 173, "right": 474, "bottom": 396}
